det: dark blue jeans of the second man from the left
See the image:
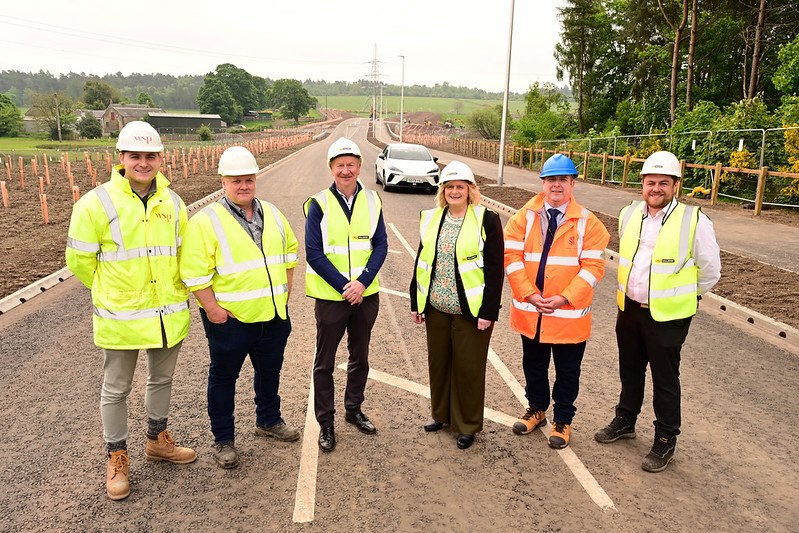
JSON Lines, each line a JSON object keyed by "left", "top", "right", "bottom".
{"left": 200, "top": 308, "right": 291, "bottom": 442}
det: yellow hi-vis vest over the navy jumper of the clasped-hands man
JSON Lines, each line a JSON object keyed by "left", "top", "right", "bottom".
{"left": 303, "top": 188, "right": 383, "bottom": 300}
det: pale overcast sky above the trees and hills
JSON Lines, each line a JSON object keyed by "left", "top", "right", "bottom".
{"left": 0, "top": 0, "right": 563, "bottom": 92}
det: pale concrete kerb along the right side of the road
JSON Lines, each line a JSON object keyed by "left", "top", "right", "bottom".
{"left": 482, "top": 196, "right": 799, "bottom": 355}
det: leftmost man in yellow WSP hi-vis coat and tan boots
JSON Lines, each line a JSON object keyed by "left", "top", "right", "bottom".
{"left": 66, "top": 121, "right": 197, "bottom": 500}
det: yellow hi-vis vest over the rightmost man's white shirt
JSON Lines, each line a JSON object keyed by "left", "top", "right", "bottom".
{"left": 616, "top": 201, "right": 699, "bottom": 322}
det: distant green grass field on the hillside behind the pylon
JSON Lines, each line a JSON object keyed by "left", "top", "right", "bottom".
{"left": 316, "top": 94, "right": 525, "bottom": 119}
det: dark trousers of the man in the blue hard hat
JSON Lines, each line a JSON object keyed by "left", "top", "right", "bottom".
{"left": 522, "top": 335, "right": 585, "bottom": 424}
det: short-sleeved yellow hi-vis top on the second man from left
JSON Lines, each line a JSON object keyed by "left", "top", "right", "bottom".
{"left": 180, "top": 199, "right": 298, "bottom": 323}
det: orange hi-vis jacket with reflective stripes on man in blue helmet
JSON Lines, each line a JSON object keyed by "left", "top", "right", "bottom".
{"left": 505, "top": 193, "right": 610, "bottom": 344}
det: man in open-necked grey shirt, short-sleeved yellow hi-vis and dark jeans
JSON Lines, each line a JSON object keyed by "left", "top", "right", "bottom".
{"left": 180, "top": 146, "right": 300, "bottom": 468}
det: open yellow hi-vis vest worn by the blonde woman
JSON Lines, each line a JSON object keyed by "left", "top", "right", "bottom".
{"left": 415, "top": 204, "right": 486, "bottom": 317}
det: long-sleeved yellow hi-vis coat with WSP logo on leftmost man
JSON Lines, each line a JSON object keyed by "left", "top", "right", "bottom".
{"left": 66, "top": 165, "right": 189, "bottom": 350}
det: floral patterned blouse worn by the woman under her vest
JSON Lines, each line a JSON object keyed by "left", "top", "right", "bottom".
{"left": 430, "top": 212, "right": 463, "bottom": 315}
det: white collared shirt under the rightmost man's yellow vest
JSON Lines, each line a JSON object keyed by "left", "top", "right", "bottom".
{"left": 627, "top": 198, "right": 721, "bottom": 304}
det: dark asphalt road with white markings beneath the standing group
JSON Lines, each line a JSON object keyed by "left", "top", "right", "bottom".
{"left": 0, "top": 119, "right": 799, "bottom": 531}
